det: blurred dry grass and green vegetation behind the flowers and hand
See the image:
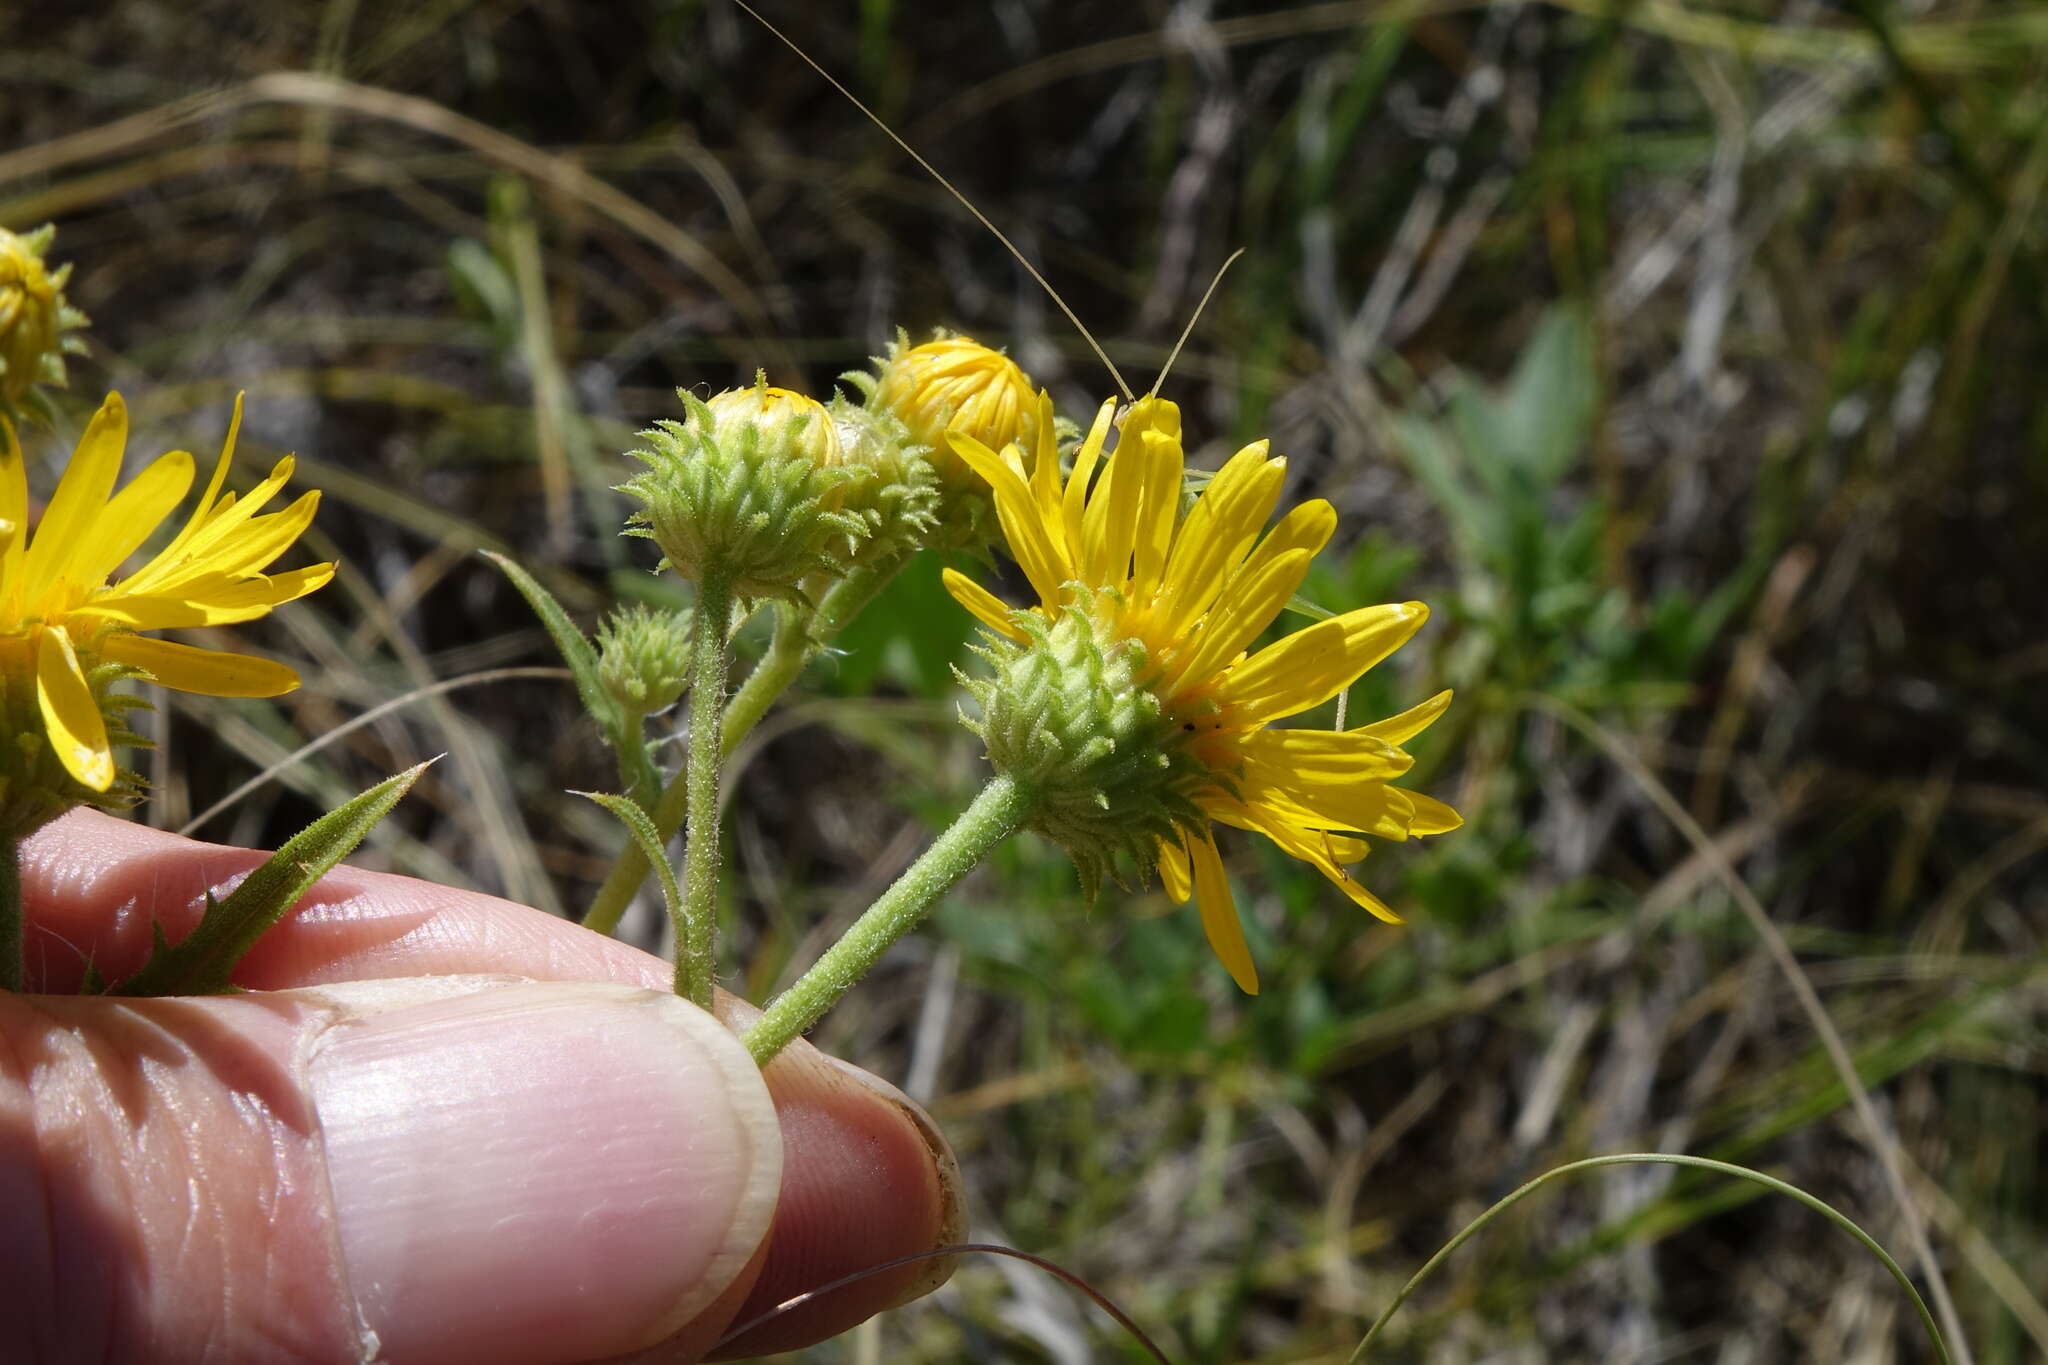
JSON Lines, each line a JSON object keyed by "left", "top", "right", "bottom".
{"left": 0, "top": 0, "right": 2048, "bottom": 1365}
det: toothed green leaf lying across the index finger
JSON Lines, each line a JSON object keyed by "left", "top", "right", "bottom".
{"left": 109, "top": 759, "right": 434, "bottom": 995}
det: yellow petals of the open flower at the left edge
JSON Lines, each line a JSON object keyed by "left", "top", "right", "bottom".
{"left": 0, "top": 393, "right": 334, "bottom": 792}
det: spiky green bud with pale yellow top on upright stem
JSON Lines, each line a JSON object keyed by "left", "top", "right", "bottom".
{"left": 621, "top": 383, "right": 866, "bottom": 602}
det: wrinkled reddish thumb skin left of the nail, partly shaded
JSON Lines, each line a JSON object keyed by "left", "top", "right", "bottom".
{"left": 0, "top": 997, "right": 358, "bottom": 1361}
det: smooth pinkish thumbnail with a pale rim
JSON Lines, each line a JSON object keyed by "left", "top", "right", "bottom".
{"left": 311, "top": 982, "right": 782, "bottom": 1365}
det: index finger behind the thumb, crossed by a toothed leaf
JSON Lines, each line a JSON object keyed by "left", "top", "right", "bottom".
{"left": 23, "top": 810, "right": 965, "bottom": 1351}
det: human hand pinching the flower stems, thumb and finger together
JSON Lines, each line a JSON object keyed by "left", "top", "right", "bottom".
{"left": 0, "top": 810, "right": 961, "bottom": 1365}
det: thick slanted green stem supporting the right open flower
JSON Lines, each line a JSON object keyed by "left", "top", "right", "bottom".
{"left": 741, "top": 774, "right": 1034, "bottom": 1066}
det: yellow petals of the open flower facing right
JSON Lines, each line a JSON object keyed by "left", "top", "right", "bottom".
{"left": 946, "top": 395, "right": 1460, "bottom": 993}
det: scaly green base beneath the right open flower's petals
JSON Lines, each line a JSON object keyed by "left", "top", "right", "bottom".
{"left": 963, "top": 585, "right": 1217, "bottom": 898}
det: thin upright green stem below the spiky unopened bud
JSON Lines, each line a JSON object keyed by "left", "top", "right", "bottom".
{"left": 664, "top": 573, "right": 733, "bottom": 1009}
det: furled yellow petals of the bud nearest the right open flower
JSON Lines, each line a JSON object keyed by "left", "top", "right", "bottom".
{"left": 872, "top": 336, "right": 1038, "bottom": 483}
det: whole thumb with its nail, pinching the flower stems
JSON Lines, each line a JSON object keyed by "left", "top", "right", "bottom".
{"left": 0, "top": 976, "right": 782, "bottom": 1365}
